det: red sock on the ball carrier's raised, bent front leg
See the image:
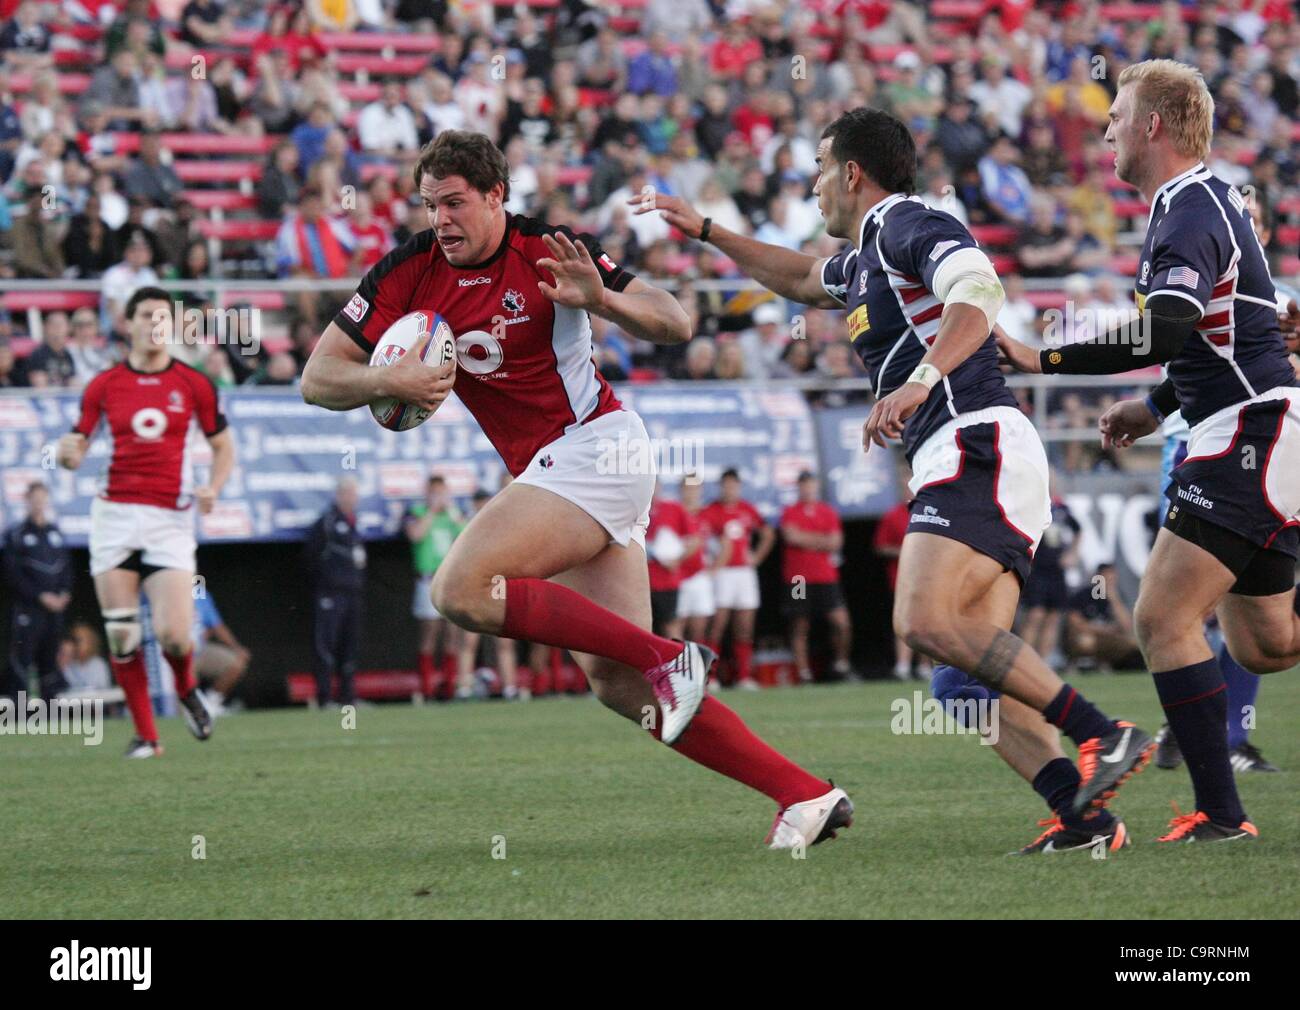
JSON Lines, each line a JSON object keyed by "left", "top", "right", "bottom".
{"left": 501, "top": 578, "right": 681, "bottom": 672}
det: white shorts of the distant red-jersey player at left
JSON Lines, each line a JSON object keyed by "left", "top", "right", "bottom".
{"left": 90, "top": 498, "right": 195, "bottom": 576}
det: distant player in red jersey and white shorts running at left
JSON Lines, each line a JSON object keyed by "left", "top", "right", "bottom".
{"left": 59, "top": 287, "right": 235, "bottom": 758}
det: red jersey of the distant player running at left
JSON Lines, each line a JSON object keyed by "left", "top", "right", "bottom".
{"left": 73, "top": 357, "right": 226, "bottom": 508}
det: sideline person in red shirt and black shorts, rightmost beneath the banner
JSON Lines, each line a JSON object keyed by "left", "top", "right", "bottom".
{"left": 780, "top": 471, "right": 853, "bottom": 684}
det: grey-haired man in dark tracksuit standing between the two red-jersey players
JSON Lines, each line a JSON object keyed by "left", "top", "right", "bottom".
{"left": 304, "top": 477, "right": 365, "bottom": 707}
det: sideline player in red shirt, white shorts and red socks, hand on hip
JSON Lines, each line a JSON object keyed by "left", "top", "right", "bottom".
{"left": 699, "top": 469, "right": 776, "bottom": 690}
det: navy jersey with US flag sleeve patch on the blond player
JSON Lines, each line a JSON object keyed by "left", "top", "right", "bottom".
{"left": 1136, "top": 165, "right": 1296, "bottom": 425}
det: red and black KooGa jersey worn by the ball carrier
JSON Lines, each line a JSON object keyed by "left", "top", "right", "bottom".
{"left": 334, "top": 214, "right": 632, "bottom": 477}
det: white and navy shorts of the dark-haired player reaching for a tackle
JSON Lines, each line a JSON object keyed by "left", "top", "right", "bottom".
{"left": 907, "top": 407, "right": 1052, "bottom": 584}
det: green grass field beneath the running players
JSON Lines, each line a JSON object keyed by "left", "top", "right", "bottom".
{"left": 0, "top": 673, "right": 1300, "bottom": 918}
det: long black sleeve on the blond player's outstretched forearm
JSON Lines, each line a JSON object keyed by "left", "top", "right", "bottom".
{"left": 1039, "top": 295, "right": 1201, "bottom": 376}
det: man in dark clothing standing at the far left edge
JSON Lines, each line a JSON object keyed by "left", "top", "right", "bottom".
{"left": 3, "top": 481, "right": 73, "bottom": 701}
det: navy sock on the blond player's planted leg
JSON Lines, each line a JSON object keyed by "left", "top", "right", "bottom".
{"left": 1152, "top": 659, "right": 1245, "bottom": 827}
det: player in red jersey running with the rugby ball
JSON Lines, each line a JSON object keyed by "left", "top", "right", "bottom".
{"left": 302, "top": 130, "right": 853, "bottom": 848}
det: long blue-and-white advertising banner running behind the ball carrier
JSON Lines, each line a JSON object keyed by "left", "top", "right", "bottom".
{"left": 0, "top": 385, "right": 819, "bottom": 546}
